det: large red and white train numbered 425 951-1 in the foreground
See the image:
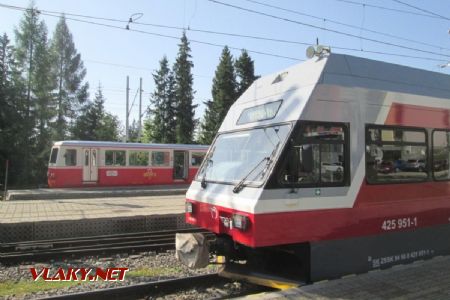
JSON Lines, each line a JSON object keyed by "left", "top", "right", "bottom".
{"left": 177, "top": 53, "right": 450, "bottom": 281}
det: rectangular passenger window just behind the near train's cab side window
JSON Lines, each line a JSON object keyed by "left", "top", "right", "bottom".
{"left": 366, "top": 125, "right": 428, "bottom": 183}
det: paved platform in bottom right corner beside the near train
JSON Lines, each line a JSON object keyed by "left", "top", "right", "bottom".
{"left": 253, "top": 256, "right": 450, "bottom": 300}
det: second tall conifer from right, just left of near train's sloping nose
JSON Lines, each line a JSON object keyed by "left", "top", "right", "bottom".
{"left": 200, "top": 47, "right": 237, "bottom": 144}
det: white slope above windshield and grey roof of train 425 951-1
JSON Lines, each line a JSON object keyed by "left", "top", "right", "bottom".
{"left": 219, "top": 53, "right": 450, "bottom": 132}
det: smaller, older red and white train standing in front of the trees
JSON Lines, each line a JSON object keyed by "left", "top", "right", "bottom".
{"left": 47, "top": 141, "right": 208, "bottom": 188}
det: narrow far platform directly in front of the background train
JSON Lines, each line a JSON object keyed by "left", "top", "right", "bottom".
{"left": 5, "top": 184, "right": 189, "bottom": 200}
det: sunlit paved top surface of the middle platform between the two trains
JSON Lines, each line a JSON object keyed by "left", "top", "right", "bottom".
{"left": 0, "top": 194, "right": 185, "bottom": 224}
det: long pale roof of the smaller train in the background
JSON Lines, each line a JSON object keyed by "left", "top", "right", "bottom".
{"left": 53, "top": 141, "right": 209, "bottom": 150}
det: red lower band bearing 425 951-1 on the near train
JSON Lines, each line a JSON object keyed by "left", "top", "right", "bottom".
{"left": 186, "top": 195, "right": 450, "bottom": 247}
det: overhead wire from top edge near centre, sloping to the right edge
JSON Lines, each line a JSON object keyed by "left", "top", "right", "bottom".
{"left": 208, "top": 0, "right": 450, "bottom": 58}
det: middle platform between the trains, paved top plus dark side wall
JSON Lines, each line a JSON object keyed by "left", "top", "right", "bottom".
{"left": 0, "top": 194, "right": 189, "bottom": 242}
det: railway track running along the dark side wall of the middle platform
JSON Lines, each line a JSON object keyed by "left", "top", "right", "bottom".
{"left": 0, "top": 228, "right": 212, "bottom": 264}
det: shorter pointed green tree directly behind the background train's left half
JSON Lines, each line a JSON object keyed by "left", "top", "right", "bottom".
{"left": 72, "top": 86, "right": 119, "bottom": 141}
